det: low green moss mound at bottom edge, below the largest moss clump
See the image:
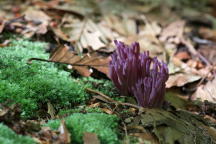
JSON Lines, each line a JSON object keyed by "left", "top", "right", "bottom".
{"left": 47, "top": 113, "right": 118, "bottom": 144}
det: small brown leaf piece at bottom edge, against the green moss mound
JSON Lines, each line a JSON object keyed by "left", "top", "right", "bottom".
{"left": 83, "top": 132, "right": 100, "bottom": 144}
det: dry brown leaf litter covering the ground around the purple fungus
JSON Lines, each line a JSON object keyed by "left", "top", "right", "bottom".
{"left": 0, "top": 0, "right": 216, "bottom": 144}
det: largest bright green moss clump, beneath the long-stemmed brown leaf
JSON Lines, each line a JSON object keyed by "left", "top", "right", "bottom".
{"left": 0, "top": 40, "right": 88, "bottom": 116}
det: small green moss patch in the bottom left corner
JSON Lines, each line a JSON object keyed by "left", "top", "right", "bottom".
{"left": 0, "top": 123, "right": 36, "bottom": 144}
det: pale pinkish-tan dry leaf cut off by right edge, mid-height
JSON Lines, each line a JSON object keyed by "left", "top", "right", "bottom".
{"left": 192, "top": 78, "right": 216, "bottom": 103}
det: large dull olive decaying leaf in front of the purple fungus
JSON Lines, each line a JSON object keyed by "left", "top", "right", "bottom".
{"left": 141, "top": 109, "right": 215, "bottom": 144}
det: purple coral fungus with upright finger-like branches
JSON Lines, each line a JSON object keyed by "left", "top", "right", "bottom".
{"left": 109, "top": 40, "right": 169, "bottom": 108}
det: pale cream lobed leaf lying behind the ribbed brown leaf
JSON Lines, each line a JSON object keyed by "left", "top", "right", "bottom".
{"left": 57, "top": 17, "right": 108, "bottom": 52}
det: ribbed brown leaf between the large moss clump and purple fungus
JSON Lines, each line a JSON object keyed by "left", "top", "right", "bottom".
{"left": 50, "top": 46, "right": 110, "bottom": 77}
